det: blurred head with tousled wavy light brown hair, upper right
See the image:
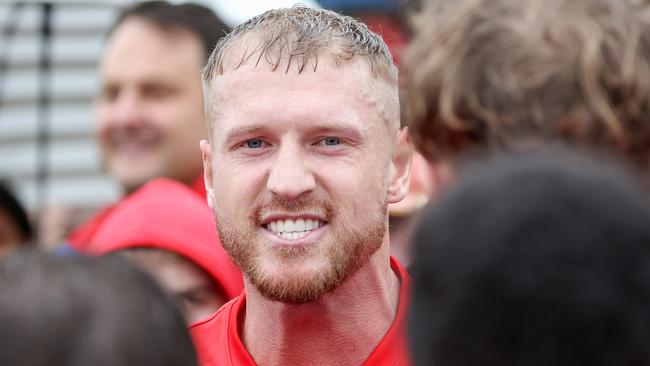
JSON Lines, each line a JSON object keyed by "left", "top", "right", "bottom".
{"left": 406, "top": 0, "right": 650, "bottom": 170}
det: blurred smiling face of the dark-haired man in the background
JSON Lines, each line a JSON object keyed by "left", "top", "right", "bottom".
{"left": 95, "top": 18, "right": 206, "bottom": 192}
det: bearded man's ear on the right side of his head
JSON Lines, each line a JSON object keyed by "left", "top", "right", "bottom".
{"left": 388, "top": 127, "right": 413, "bottom": 203}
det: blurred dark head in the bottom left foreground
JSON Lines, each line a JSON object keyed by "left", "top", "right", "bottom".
{"left": 0, "top": 252, "right": 197, "bottom": 366}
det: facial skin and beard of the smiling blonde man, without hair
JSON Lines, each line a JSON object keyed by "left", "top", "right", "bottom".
{"left": 201, "top": 56, "right": 410, "bottom": 303}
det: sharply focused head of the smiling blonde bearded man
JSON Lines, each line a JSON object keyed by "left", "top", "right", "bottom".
{"left": 201, "top": 6, "right": 411, "bottom": 303}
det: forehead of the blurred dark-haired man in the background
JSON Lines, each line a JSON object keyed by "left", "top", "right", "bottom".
{"left": 101, "top": 18, "right": 203, "bottom": 78}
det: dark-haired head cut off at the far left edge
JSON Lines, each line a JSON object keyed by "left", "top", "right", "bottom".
{"left": 0, "top": 182, "right": 33, "bottom": 258}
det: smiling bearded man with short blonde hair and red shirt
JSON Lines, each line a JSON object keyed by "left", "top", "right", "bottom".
{"left": 191, "top": 6, "right": 411, "bottom": 365}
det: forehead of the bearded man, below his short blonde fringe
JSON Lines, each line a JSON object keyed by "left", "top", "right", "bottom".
{"left": 206, "top": 56, "right": 399, "bottom": 137}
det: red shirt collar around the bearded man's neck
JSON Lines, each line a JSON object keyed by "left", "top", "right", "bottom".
{"left": 190, "top": 257, "right": 410, "bottom": 366}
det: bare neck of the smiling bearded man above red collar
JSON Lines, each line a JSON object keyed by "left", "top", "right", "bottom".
{"left": 242, "top": 240, "right": 400, "bottom": 365}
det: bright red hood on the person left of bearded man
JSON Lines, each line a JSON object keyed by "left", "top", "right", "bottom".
{"left": 86, "top": 179, "right": 244, "bottom": 299}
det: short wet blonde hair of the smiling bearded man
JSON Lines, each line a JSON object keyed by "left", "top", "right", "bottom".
{"left": 202, "top": 5, "right": 397, "bottom": 126}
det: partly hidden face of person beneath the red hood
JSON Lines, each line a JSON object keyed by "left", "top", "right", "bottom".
{"left": 122, "top": 249, "right": 226, "bottom": 325}
